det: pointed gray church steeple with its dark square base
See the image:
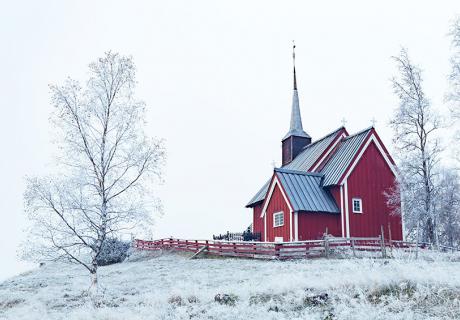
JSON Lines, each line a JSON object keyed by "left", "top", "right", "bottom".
{"left": 282, "top": 44, "right": 311, "bottom": 166}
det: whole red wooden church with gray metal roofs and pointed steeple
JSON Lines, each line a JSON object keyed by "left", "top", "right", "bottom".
{"left": 246, "top": 52, "right": 403, "bottom": 241}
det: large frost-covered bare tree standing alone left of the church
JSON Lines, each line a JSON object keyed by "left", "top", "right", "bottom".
{"left": 24, "top": 52, "right": 165, "bottom": 293}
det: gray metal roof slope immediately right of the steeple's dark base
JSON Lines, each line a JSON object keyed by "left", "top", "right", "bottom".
{"left": 283, "top": 127, "right": 343, "bottom": 171}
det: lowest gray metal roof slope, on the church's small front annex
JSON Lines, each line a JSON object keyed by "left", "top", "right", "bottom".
{"left": 275, "top": 169, "right": 340, "bottom": 213}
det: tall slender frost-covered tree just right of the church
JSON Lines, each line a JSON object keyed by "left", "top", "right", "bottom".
{"left": 390, "top": 49, "right": 440, "bottom": 243}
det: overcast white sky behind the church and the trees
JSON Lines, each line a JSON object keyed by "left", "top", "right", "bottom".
{"left": 0, "top": 0, "right": 460, "bottom": 279}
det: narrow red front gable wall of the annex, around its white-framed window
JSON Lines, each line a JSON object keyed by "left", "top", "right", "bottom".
{"left": 265, "top": 185, "right": 291, "bottom": 241}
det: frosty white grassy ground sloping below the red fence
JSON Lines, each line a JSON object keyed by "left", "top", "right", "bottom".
{"left": 0, "top": 250, "right": 460, "bottom": 320}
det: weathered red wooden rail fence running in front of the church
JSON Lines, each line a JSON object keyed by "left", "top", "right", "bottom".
{"left": 133, "top": 236, "right": 460, "bottom": 259}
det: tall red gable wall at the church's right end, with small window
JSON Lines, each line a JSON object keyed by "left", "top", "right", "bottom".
{"left": 347, "top": 142, "right": 402, "bottom": 240}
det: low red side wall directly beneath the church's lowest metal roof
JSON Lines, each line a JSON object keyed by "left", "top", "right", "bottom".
{"left": 298, "top": 212, "right": 342, "bottom": 241}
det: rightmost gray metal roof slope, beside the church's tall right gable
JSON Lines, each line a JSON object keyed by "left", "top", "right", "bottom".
{"left": 321, "top": 127, "right": 372, "bottom": 187}
